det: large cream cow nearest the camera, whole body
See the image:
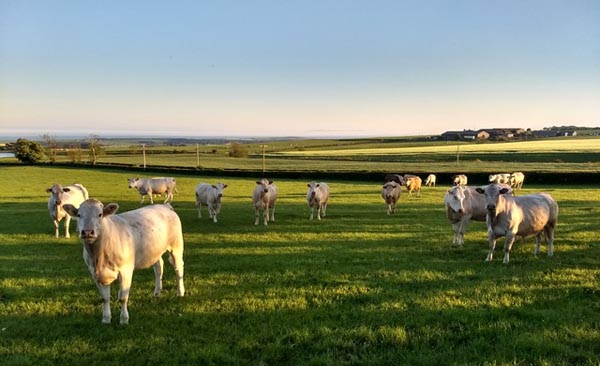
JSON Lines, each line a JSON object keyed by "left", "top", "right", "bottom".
{"left": 64, "top": 198, "right": 185, "bottom": 324}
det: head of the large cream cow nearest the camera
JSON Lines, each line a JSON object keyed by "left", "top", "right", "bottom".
{"left": 64, "top": 198, "right": 119, "bottom": 245}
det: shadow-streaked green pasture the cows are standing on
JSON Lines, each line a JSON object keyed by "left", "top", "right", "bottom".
{"left": 0, "top": 166, "right": 600, "bottom": 365}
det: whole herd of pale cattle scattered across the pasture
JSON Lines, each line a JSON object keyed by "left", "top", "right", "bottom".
{"left": 47, "top": 172, "right": 558, "bottom": 324}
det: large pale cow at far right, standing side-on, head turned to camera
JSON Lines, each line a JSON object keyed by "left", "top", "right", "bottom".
{"left": 476, "top": 184, "right": 558, "bottom": 264}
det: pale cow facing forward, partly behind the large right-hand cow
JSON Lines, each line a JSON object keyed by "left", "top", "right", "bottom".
{"left": 444, "top": 186, "right": 487, "bottom": 245}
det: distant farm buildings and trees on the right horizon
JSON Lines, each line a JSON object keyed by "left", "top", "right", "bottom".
{"left": 439, "top": 126, "right": 600, "bottom": 141}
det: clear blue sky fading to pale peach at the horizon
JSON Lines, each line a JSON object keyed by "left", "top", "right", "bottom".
{"left": 0, "top": 0, "right": 600, "bottom": 136}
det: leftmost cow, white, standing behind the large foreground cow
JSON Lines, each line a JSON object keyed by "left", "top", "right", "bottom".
{"left": 46, "top": 183, "right": 89, "bottom": 239}
